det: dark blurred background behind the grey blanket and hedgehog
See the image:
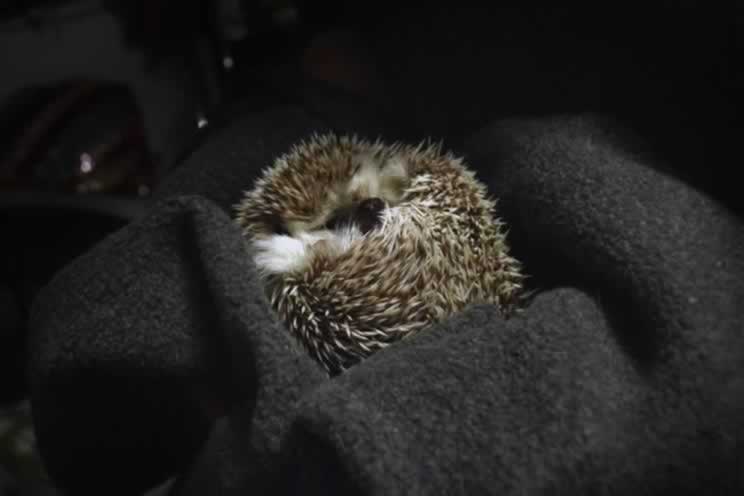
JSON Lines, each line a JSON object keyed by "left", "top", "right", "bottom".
{"left": 0, "top": 0, "right": 744, "bottom": 494}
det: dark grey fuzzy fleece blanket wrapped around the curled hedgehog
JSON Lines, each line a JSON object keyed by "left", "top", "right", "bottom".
{"left": 29, "top": 103, "right": 744, "bottom": 496}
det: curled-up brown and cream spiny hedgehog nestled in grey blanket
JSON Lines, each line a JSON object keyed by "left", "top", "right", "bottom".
{"left": 236, "top": 134, "right": 524, "bottom": 375}
